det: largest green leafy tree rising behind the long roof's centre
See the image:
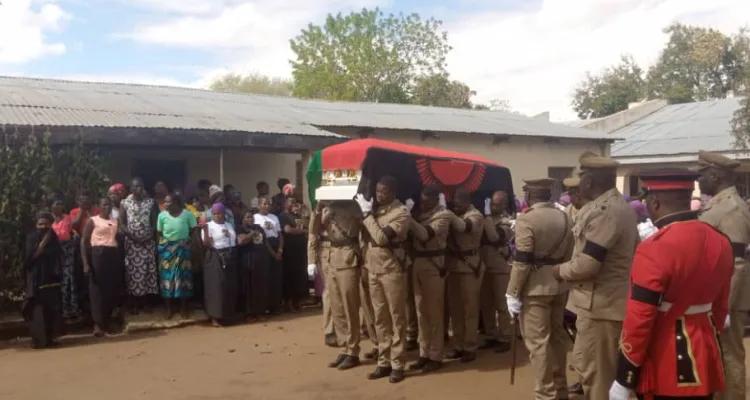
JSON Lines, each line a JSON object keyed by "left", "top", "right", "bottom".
{"left": 290, "top": 8, "right": 451, "bottom": 103}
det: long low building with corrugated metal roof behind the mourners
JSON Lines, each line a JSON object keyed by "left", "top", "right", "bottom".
{"left": 0, "top": 77, "right": 613, "bottom": 202}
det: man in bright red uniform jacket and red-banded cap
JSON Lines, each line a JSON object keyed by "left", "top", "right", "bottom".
{"left": 609, "top": 169, "right": 734, "bottom": 400}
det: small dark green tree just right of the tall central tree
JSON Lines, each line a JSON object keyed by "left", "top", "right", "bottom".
{"left": 412, "top": 73, "right": 477, "bottom": 108}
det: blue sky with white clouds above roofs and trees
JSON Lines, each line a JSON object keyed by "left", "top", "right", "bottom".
{"left": 0, "top": 0, "right": 750, "bottom": 121}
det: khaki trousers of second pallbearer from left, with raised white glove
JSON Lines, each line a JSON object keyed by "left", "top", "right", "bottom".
{"left": 368, "top": 271, "right": 406, "bottom": 370}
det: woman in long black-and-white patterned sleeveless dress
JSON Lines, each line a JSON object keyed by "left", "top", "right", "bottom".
{"left": 119, "top": 178, "right": 159, "bottom": 314}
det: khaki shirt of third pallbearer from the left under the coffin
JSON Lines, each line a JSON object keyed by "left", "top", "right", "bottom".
{"left": 411, "top": 205, "right": 455, "bottom": 272}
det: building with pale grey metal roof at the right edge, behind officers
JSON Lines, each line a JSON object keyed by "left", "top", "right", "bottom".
{"left": 568, "top": 98, "right": 750, "bottom": 197}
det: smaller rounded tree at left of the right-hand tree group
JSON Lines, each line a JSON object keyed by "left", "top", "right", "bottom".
{"left": 572, "top": 55, "right": 646, "bottom": 119}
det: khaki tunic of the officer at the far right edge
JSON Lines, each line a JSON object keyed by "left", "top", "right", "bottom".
{"left": 699, "top": 186, "right": 750, "bottom": 311}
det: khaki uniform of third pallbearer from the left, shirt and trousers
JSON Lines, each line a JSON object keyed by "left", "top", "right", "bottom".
{"left": 411, "top": 205, "right": 454, "bottom": 362}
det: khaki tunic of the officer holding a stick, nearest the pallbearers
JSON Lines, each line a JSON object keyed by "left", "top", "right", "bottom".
{"left": 507, "top": 203, "right": 575, "bottom": 298}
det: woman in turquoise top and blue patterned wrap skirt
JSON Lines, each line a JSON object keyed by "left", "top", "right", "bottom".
{"left": 156, "top": 194, "right": 198, "bottom": 319}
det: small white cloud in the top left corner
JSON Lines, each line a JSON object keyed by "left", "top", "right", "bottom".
{"left": 0, "top": 0, "right": 71, "bottom": 65}
